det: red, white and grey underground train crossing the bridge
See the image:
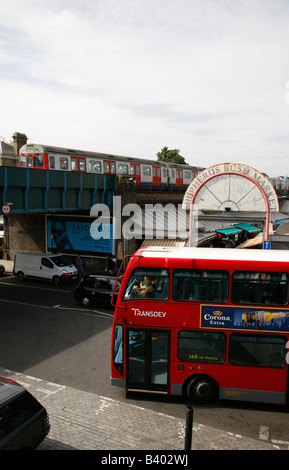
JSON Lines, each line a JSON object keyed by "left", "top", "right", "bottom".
{"left": 18, "top": 144, "right": 204, "bottom": 188}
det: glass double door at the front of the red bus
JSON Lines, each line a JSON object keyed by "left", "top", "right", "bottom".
{"left": 126, "top": 328, "right": 170, "bottom": 393}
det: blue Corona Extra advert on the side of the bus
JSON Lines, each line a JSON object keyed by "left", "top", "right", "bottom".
{"left": 201, "top": 305, "right": 289, "bottom": 332}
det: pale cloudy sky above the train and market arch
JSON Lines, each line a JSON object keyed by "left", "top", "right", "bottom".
{"left": 0, "top": 0, "right": 289, "bottom": 176}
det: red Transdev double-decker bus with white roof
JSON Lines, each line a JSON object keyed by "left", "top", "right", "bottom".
{"left": 111, "top": 247, "right": 289, "bottom": 404}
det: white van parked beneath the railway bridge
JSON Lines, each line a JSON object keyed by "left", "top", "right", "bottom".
{"left": 13, "top": 253, "right": 77, "bottom": 285}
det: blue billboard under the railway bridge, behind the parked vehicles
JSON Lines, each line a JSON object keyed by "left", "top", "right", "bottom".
{"left": 47, "top": 218, "right": 112, "bottom": 253}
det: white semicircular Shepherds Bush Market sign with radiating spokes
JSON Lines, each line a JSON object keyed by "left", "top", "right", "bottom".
{"left": 183, "top": 163, "right": 279, "bottom": 212}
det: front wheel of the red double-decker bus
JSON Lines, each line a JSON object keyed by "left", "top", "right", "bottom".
{"left": 187, "top": 375, "right": 218, "bottom": 404}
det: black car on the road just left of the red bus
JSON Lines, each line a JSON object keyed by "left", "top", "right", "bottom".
{"left": 74, "top": 273, "right": 122, "bottom": 307}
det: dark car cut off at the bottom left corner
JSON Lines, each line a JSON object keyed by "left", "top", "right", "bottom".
{"left": 0, "top": 377, "right": 50, "bottom": 450}
